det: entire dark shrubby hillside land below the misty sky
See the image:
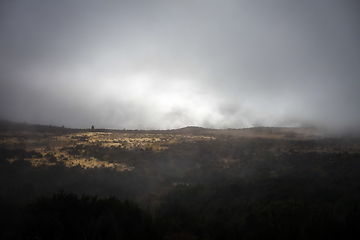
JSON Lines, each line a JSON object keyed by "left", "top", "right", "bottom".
{"left": 0, "top": 122, "right": 360, "bottom": 239}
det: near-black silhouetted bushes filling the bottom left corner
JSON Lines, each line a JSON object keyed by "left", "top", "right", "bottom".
{"left": 1, "top": 191, "right": 162, "bottom": 239}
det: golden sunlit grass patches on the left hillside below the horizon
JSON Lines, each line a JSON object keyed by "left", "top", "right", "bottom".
{"left": 0, "top": 131, "right": 215, "bottom": 171}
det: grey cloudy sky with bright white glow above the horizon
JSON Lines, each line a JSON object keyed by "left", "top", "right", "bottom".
{"left": 0, "top": 0, "right": 360, "bottom": 129}
